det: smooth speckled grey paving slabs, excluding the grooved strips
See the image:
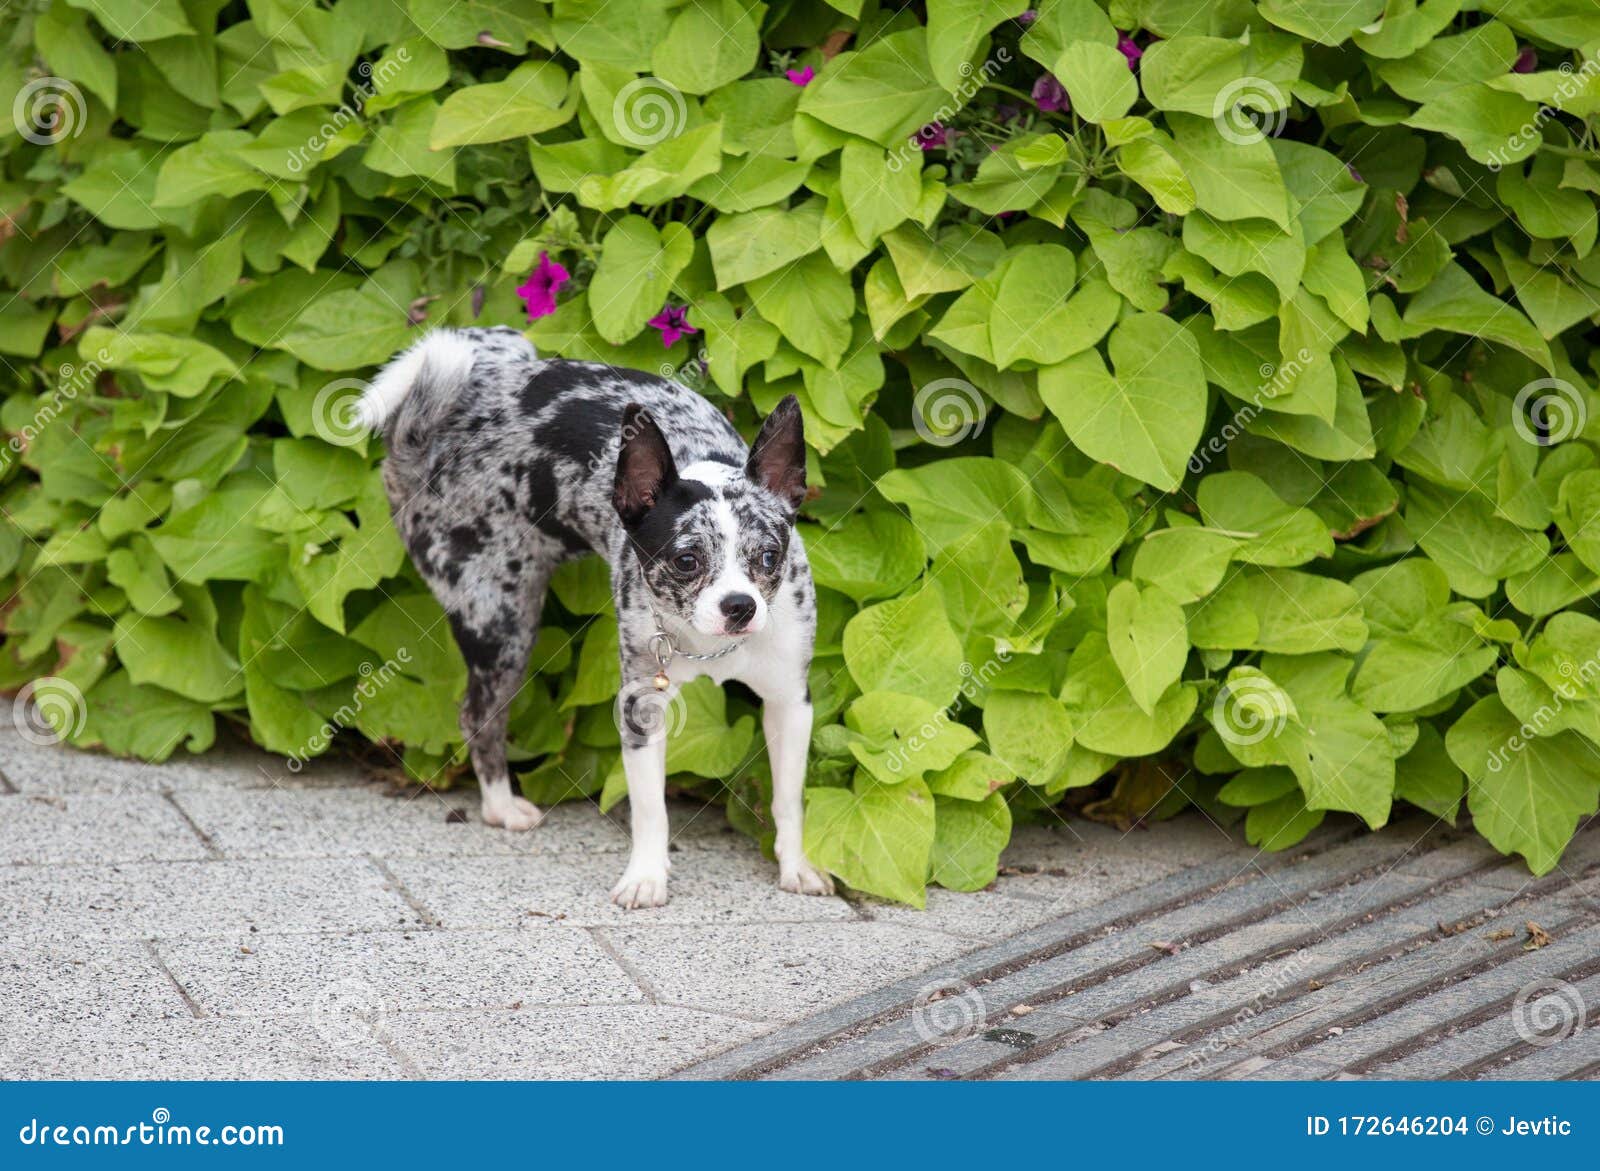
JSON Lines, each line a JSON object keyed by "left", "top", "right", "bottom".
{"left": 0, "top": 721, "right": 1256, "bottom": 1078}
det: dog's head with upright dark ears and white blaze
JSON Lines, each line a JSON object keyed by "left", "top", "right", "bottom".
{"left": 611, "top": 395, "right": 805, "bottom": 637}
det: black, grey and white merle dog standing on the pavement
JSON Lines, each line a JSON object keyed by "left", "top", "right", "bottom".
{"left": 358, "top": 326, "right": 832, "bottom": 907}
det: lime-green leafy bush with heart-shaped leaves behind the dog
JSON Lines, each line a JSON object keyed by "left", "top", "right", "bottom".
{"left": 0, "top": 0, "right": 1600, "bottom": 902}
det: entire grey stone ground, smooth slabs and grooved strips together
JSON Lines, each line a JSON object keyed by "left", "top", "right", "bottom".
{"left": 0, "top": 721, "right": 1600, "bottom": 1078}
